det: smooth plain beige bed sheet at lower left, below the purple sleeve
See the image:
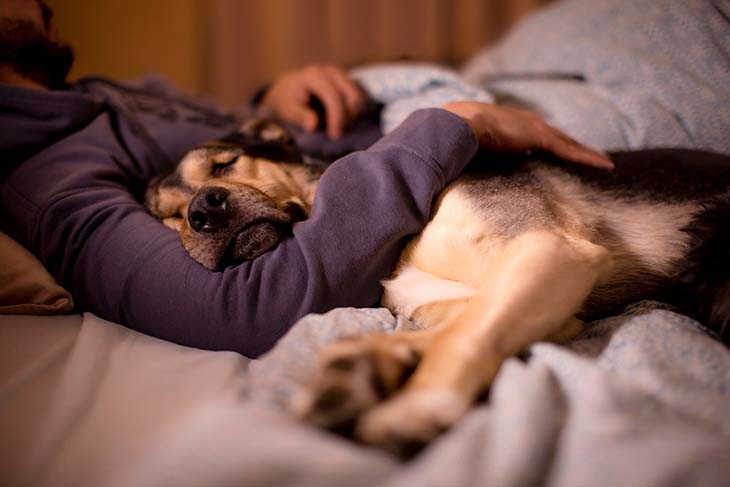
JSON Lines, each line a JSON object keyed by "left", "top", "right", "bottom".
{"left": 0, "top": 314, "right": 248, "bottom": 485}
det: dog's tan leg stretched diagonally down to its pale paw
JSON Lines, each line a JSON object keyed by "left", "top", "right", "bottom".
{"left": 356, "top": 231, "right": 611, "bottom": 453}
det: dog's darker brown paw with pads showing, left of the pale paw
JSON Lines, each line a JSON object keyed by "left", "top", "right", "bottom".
{"left": 292, "top": 334, "right": 420, "bottom": 432}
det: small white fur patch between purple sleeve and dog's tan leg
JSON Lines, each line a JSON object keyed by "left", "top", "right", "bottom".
{"left": 383, "top": 266, "right": 476, "bottom": 318}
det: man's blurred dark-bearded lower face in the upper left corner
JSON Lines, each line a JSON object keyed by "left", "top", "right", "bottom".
{"left": 0, "top": 0, "right": 73, "bottom": 88}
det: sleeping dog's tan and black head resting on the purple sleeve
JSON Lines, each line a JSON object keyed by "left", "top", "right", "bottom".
{"left": 145, "top": 119, "right": 321, "bottom": 270}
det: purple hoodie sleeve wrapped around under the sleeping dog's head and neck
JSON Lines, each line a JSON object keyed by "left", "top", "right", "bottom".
{"left": 5, "top": 109, "right": 477, "bottom": 357}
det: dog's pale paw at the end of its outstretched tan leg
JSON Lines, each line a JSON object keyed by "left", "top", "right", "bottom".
{"left": 355, "top": 389, "right": 469, "bottom": 457}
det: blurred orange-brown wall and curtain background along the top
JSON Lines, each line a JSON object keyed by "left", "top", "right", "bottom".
{"left": 47, "top": 0, "right": 547, "bottom": 105}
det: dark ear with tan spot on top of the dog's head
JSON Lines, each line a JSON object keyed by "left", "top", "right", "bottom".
{"left": 221, "top": 117, "right": 303, "bottom": 162}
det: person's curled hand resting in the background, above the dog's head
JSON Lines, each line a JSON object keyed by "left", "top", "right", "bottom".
{"left": 259, "top": 64, "right": 366, "bottom": 139}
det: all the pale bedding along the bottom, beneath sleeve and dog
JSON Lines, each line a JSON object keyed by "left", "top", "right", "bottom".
{"left": 0, "top": 305, "right": 730, "bottom": 487}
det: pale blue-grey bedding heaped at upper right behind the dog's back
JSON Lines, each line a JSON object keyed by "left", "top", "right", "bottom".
{"left": 462, "top": 0, "right": 730, "bottom": 153}
